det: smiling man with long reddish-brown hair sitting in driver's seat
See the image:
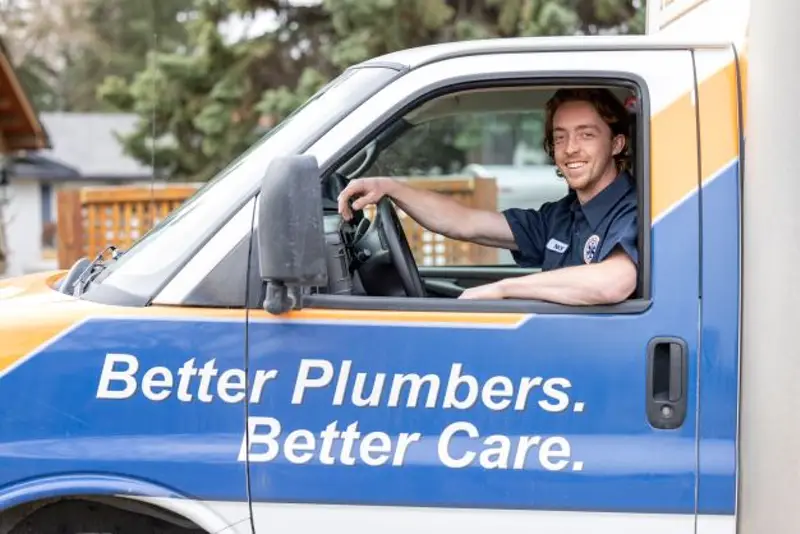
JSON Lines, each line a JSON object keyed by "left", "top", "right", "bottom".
{"left": 339, "top": 89, "right": 639, "bottom": 305}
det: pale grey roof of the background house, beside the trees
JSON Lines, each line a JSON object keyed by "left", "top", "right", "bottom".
{"left": 40, "top": 112, "right": 151, "bottom": 180}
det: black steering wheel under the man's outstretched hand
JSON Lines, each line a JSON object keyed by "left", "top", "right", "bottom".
{"left": 354, "top": 197, "right": 425, "bottom": 297}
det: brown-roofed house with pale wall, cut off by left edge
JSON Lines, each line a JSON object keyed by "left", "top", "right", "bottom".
{"left": 0, "top": 40, "right": 51, "bottom": 277}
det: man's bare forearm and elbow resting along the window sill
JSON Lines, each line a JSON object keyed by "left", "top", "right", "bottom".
{"left": 460, "top": 247, "right": 636, "bottom": 306}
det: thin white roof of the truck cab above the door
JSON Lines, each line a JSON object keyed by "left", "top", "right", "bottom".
{"left": 362, "top": 35, "right": 731, "bottom": 69}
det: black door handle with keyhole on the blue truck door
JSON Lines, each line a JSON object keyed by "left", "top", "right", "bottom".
{"left": 646, "top": 337, "right": 689, "bottom": 429}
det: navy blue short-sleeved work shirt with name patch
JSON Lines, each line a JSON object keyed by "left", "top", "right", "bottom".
{"left": 503, "top": 172, "right": 639, "bottom": 271}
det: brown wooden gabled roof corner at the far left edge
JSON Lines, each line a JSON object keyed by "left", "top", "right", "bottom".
{"left": 0, "top": 40, "right": 50, "bottom": 153}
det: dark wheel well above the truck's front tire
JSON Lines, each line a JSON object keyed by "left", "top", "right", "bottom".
{"left": 0, "top": 495, "right": 209, "bottom": 534}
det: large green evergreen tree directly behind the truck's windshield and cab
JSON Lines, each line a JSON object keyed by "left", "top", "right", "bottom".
{"left": 101, "top": 0, "right": 643, "bottom": 180}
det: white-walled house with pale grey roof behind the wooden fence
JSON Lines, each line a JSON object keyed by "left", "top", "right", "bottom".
{"left": 1, "top": 112, "right": 152, "bottom": 275}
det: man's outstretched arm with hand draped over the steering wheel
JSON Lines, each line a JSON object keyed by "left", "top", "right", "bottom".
{"left": 338, "top": 178, "right": 516, "bottom": 250}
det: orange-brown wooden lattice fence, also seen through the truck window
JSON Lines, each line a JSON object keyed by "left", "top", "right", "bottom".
{"left": 57, "top": 178, "right": 497, "bottom": 269}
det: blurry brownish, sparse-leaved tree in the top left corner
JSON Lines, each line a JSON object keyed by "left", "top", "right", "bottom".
{"left": 0, "top": 0, "right": 192, "bottom": 111}
